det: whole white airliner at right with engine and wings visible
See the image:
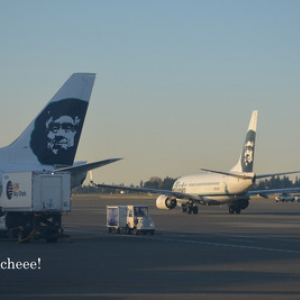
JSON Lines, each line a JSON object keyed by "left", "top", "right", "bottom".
{"left": 92, "top": 110, "right": 300, "bottom": 214}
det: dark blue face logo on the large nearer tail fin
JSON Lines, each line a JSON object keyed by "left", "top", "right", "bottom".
{"left": 30, "top": 99, "right": 88, "bottom": 165}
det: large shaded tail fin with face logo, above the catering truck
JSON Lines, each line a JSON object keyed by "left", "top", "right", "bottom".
{"left": 0, "top": 73, "right": 95, "bottom": 166}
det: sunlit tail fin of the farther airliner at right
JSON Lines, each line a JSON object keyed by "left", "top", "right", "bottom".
{"left": 230, "top": 110, "right": 258, "bottom": 173}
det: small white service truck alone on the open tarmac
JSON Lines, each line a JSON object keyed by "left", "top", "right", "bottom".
{"left": 106, "top": 205, "right": 155, "bottom": 235}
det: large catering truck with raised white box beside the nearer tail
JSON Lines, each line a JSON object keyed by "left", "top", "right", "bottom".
{"left": 0, "top": 172, "right": 71, "bottom": 243}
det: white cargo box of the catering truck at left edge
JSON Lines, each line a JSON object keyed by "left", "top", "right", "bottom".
{"left": 0, "top": 172, "right": 71, "bottom": 212}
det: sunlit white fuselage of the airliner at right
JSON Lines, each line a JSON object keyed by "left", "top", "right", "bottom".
{"left": 173, "top": 173, "right": 254, "bottom": 204}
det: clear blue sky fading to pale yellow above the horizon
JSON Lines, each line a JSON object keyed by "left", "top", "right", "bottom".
{"left": 0, "top": 0, "right": 300, "bottom": 184}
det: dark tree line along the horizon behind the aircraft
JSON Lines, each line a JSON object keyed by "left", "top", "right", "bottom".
{"left": 74, "top": 176, "right": 300, "bottom": 194}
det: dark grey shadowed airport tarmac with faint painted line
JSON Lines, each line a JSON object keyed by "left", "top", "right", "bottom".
{"left": 0, "top": 194, "right": 300, "bottom": 300}
